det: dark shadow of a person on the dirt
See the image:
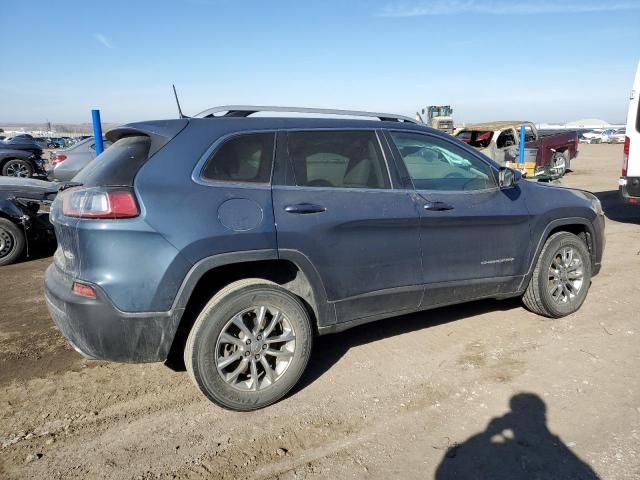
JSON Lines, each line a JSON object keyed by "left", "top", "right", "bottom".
{"left": 435, "top": 393, "right": 600, "bottom": 480}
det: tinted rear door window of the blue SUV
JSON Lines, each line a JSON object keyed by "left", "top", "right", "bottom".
{"left": 287, "top": 131, "right": 389, "bottom": 188}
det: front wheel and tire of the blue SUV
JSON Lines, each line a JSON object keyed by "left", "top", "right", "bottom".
{"left": 522, "top": 232, "right": 591, "bottom": 318}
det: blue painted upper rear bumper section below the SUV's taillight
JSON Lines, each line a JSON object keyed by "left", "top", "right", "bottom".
{"left": 52, "top": 208, "right": 191, "bottom": 312}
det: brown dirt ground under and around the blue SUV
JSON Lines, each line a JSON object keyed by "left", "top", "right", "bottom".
{"left": 0, "top": 145, "right": 640, "bottom": 480}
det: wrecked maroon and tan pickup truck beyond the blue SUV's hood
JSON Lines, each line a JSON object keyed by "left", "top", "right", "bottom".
{"left": 456, "top": 121, "right": 578, "bottom": 177}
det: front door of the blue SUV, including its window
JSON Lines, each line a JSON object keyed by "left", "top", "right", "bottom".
{"left": 388, "top": 131, "right": 531, "bottom": 306}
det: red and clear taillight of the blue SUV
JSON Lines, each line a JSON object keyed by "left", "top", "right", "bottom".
{"left": 62, "top": 187, "right": 140, "bottom": 218}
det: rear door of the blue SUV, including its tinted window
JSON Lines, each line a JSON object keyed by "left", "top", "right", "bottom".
{"left": 272, "top": 129, "right": 422, "bottom": 323}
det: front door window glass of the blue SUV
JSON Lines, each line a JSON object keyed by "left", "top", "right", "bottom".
{"left": 391, "top": 132, "right": 497, "bottom": 191}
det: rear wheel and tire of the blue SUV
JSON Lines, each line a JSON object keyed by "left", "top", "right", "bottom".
{"left": 184, "top": 279, "right": 313, "bottom": 411}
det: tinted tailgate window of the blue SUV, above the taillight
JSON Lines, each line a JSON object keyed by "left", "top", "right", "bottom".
{"left": 73, "top": 135, "right": 151, "bottom": 186}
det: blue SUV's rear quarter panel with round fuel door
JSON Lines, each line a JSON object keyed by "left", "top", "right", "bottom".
{"left": 134, "top": 119, "right": 277, "bottom": 263}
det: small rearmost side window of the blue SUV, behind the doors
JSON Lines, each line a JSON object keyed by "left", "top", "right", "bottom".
{"left": 202, "top": 132, "right": 275, "bottom": 183}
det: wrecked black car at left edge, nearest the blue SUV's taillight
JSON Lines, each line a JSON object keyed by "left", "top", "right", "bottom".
{"left": 0, "top": 177, "right": 58, "bottom": 266}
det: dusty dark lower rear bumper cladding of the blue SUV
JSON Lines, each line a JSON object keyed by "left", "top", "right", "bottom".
{"left": 44, "top": 264, "right": 179, "bottom": 363}
